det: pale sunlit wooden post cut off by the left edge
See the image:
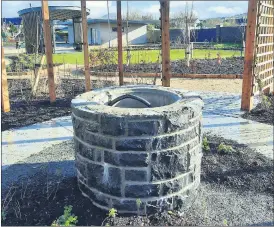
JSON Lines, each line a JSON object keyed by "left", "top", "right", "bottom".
{"left": 1, "top": 42, "right": 10, "bottom": 112}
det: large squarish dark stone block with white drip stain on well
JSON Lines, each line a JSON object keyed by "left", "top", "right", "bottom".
{"left": 87, "top": 163, "right": 121, "bottom": 196}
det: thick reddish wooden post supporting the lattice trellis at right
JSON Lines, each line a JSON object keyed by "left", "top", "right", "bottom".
{"left": 241, "top": 0, "right": 258, "bottom": 111}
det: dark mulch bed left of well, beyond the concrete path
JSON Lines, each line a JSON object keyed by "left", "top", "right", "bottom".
{"left": 1, "top": 80, "right": 76, "bottom": 131}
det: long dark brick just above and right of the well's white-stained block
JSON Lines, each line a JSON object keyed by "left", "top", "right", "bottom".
{"left": 104, "top": 151, "right": 148, "bottom": 167}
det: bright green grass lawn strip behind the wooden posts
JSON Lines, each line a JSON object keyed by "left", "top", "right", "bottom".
{"left": 50, "top": 49, "right": 241, "bottom": 65}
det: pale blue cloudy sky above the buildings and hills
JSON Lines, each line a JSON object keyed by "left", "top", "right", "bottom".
{"left": 1, "top": 1, "right": 248, "bottom": 19}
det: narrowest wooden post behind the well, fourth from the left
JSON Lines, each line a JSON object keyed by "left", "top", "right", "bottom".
{"left": 117, "top": 0, "right": 124, "bottom": 86}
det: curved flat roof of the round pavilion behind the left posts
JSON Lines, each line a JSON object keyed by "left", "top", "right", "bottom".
{"left": 18, "top": 6, "right": 89, "bottom": 20}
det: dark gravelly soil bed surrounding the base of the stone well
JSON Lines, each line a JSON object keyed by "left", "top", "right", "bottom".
{"left": 2, "top": 135, "right": 274, "bottom": 226}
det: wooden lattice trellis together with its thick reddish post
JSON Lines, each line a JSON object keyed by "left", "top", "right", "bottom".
{"left": 242, "top": 0, "right": 274, "bottom": 111}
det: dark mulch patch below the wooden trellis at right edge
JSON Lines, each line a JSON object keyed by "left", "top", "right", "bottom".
{"left": 242, "top": 95, "right": 274, "bottom": 125}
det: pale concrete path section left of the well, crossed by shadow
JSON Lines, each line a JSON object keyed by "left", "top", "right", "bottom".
{"left": 2, "top": 120, "right": 73, "bottom": 169}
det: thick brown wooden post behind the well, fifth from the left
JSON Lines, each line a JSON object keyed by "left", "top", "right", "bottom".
{"left": 160, "top": 0, "right": 171, "bottom": 87}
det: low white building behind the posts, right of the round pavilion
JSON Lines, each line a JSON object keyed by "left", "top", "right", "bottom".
{"left": 67, "top": 19, "right": 147, "bottom": 47}
